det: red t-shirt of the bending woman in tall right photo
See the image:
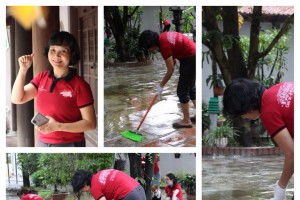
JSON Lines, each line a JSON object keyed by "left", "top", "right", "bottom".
{"left": 260, "top": 82, "right": 294, "bottom": 138}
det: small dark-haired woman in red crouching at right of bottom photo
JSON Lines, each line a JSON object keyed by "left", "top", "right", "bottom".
{"left": 165, "top": 173, "right": 183, "bottom": 200}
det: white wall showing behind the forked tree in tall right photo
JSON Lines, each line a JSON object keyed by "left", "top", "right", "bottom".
{"left": 203, "top": 22, "right": 294, "bottom": 105}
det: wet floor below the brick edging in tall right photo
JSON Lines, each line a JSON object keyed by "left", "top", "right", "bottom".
{"left": 202, "top": 156, "right": 294, "bottom": 200}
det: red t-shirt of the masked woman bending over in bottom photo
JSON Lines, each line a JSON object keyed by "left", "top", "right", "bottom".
{"left": 91, "top": 169, "right": 139, "bottom": 200}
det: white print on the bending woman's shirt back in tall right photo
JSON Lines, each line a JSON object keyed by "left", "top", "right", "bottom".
{"left": 277, "top": 82, "right": 294, "bottom": 108}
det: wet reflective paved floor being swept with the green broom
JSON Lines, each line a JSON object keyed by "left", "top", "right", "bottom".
{"left": 104, "top": 59, "right": 195, "bottom": 146}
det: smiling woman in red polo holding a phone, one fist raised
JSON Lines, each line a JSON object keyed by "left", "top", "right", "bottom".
{"left": 11, "top": 32, "right": 96, "bottom": 147}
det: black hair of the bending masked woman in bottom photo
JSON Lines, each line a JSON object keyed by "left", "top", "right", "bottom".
{"left": 71, "top": 169, "right": 93, "bottom": 194}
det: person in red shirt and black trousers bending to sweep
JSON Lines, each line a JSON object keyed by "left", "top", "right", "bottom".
{"left": 138, "top": 30, "right": 196, "bottom": 128}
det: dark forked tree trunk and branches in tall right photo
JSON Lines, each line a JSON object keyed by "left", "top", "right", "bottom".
{"left": 202, "top": 6, "right": 294, "bottom": 85}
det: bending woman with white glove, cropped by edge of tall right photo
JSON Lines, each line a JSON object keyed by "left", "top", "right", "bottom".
{"left": 223, "top": 78, "right": 294, "bottom": 200}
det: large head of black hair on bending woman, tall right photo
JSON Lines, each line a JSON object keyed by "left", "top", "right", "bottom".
{"left": 223, "top": 78, "right": 265, "bottom": 117}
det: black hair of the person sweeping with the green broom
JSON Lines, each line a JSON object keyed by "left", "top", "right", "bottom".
{"left": 139, "top": 30, "right": 159, "bottom": 50}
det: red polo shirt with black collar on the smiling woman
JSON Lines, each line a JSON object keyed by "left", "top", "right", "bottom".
{"left": 31, "top": 69, "right": 94, "bottom": 144}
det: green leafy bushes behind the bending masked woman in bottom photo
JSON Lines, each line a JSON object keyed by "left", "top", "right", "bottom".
{"left": 30, "top": 153, "right": 114, "bottom": 190}
